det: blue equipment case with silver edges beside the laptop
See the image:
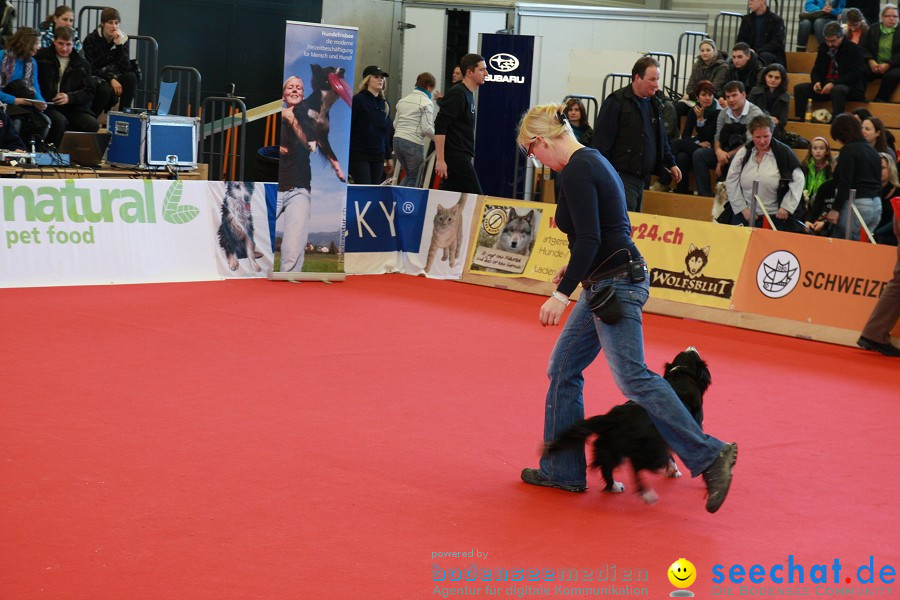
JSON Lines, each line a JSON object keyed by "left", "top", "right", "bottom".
{"left": 106, "top": 111, "right": 200, "bottom": 169}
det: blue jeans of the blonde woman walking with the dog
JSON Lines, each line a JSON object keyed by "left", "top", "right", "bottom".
{"left": 541, "top": 276, "right": 725, "bottom": 485}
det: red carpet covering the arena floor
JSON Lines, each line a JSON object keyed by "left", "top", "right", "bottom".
{"left": 0, "top": 275, "right": 900, "bottom": 599}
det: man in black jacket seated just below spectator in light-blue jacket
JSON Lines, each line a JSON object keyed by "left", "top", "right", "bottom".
{"left": 794, "top": 22, "right": 866, "bottom": 120}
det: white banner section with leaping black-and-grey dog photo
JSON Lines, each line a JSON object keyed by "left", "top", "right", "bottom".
{"left": 207, "top": 181, "right": 274, "bottom": 277}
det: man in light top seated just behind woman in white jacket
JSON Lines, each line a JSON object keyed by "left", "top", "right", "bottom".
{"left": 691, "top": 81, "right": 765, "bottom": 196}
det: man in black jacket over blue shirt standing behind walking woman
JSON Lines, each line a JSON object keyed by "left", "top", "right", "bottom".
{"left": 593, "top": 56, "right": 681, "bottom": 212}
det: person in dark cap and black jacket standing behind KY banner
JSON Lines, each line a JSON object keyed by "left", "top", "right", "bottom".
{"left": 349, "top": 65, "right": 394, "bottom": 185}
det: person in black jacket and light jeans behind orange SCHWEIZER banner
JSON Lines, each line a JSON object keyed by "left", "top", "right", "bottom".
{"left": 825, "top": 113, "right": 881, "bottom": 240}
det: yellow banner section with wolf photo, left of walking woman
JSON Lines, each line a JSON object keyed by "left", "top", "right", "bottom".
{"left": 468, "top": 197, "right": 569, "bottom": 281}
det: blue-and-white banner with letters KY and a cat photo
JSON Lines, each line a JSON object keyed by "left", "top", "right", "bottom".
{"left": 344, "top": 185, "right": 477, "bottom": 279}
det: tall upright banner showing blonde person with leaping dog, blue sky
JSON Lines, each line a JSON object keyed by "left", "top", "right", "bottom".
{"left": 275, "top": 21, "right": 358, "bottom": 273}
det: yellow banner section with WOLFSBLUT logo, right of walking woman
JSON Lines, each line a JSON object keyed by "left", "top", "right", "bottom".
{"left": 628, "top": 213, "right": 750, "bottom": 310}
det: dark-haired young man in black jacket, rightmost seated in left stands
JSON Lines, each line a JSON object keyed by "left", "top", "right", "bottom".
{"left": 84, "top": 7, "right": 137, "bottom": 115}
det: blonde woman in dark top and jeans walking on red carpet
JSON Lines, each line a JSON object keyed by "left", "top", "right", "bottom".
{"left": 517, "top": 104, "right": 737, "bottom": 512}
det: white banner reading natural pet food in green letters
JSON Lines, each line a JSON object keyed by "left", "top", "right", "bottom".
{"left": 0, "top": 179, "right": 219, "bottom": 287}
